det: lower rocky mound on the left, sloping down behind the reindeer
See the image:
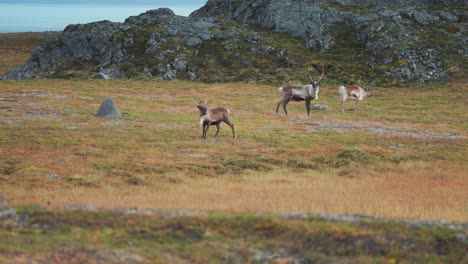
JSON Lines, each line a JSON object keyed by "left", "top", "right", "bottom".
{"left": 3, "top": 8, "right": 299, "bottom": 82}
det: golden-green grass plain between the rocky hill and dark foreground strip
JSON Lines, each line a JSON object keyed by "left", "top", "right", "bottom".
{"left": 0, "top": 80, "right": 468, "bottom": 221}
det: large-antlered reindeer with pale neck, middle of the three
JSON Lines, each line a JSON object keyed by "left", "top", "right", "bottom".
{"left": 276, "top": 65, "right": 325, "bottom": 116}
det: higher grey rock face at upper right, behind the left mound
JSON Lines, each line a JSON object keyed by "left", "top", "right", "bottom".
{"left": 191, "top": 0, "right": 468, "bottom": 82}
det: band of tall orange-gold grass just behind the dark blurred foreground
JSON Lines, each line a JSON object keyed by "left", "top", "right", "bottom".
{"left": 4, "top": 164, "right": 468, "bottom": 221}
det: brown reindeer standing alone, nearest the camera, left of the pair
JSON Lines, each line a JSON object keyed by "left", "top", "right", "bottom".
{"left": 192, "top": 98, "right": 236, "bottom": 141}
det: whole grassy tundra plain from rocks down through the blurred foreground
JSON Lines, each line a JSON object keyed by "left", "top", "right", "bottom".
{"left": 0, "top": 32, "right": 468, "bottom": 262}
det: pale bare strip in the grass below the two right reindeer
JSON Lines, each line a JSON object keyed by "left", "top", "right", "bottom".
{"left": 308, "top": 121, "right": 465, "bottom": 140}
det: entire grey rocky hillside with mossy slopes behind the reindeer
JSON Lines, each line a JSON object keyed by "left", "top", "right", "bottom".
{"left": 3, "top": 0, "right": 468, "bottom": 84}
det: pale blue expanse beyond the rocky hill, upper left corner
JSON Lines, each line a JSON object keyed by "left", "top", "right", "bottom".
{"left": 0, "top": 0, "right": 207, "bottom": 33}
